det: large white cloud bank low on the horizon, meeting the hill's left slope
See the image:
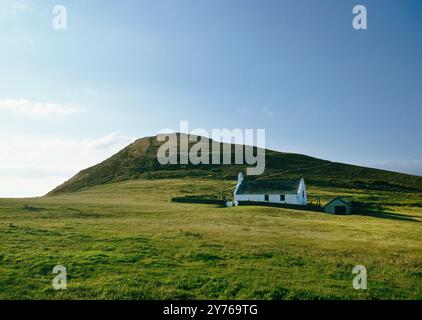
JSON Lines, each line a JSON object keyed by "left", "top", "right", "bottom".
{"left": 0, "top": 132, "right": 135, "bottom": 197}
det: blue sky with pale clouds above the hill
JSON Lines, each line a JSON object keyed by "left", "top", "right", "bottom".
{"left": 0, "top": 0, "right": 422, "bottom": 197}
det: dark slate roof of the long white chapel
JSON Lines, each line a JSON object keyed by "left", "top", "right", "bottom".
{"left": 236, "top": 179, "right": 300, "bottom": 195}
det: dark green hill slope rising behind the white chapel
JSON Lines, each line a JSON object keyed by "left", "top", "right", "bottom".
{"left": 48, "top": 133, "right": 422, "bottom": 195}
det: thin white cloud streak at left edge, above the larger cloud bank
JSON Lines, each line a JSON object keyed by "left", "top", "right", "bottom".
{"left": 0, "top": 99, "right": 85, "bottom": 117}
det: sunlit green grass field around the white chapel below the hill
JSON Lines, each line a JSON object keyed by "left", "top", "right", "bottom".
{"left": 0, "top": 178, "right": 422, "bottom": 299}
